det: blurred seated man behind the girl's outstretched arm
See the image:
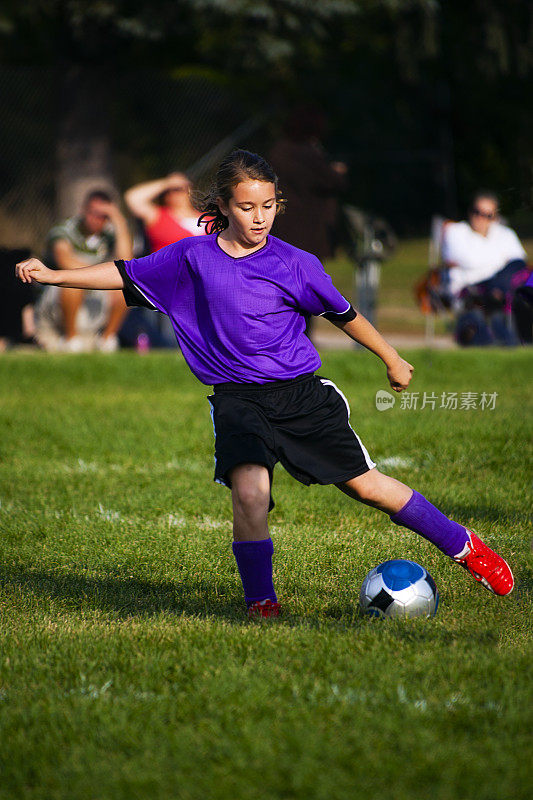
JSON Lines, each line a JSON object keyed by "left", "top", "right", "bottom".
{"left": 43, "top": 189, "right": 133, "bottom": 353}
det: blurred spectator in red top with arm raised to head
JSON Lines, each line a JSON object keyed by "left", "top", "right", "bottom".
{"left": 124, "top": 172, "right": 205, "bottom": 253}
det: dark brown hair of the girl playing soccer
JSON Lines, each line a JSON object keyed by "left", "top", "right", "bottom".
{"left": 196, "top": 150, "right": 285, "bottom": 233}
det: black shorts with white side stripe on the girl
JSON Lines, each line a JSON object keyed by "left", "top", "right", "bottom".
{"left": 208, "top": 375, "right": 376, "bottom": 508}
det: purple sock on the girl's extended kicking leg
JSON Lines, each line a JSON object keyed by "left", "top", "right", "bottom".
{"left": 391, "top": 492, "right": 469, "bottom": 558}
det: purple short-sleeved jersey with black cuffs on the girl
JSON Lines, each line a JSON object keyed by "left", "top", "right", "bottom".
{"left": 115, "top": 234, "right": 355, "bottom": 385}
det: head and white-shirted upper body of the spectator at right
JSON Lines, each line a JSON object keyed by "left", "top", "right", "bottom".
{"left": 442, "top": 191, "right": 526, "bottom": 303}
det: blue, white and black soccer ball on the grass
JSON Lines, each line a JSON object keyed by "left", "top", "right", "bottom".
{"left": 359, "top": 558, "right": 439, "bottom": 617}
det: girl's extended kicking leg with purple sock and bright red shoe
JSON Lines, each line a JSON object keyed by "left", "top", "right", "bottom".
{"left": 337, "top": 469, "right": 514, "bottom": 595}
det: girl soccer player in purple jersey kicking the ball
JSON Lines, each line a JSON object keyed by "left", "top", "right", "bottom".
{"left": 17, "top": 150, "right": 513, "bottom": 617}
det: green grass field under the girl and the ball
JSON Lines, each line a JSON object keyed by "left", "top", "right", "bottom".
{"left": 0, "top": 350, "right": 533, "bottom": 800}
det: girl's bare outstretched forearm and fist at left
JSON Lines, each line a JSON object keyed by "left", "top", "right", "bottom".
{"left": 15, "top": 258, "right": 124, "bottom": 289}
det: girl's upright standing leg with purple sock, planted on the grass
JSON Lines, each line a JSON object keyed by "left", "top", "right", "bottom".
{"left": 229, "top": 464, "right": 279, "bottom": 616}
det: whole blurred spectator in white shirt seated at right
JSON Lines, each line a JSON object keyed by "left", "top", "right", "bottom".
{"left": 442, "top": 191, "right": 526, "bottom": 344}
